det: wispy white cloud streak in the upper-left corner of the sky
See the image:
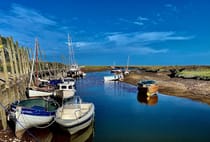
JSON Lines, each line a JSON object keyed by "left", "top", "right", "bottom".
{"left": 0, "top": 4, "right": 57, "bottom": 36}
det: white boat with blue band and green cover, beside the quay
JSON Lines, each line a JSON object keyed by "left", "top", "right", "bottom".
{"left": 9, "top": 98, "right": 59, "bottom": 138}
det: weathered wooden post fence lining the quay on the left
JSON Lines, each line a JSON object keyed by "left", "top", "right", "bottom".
{"left": 0, "top": 36, "right": 66, "bottom": 129}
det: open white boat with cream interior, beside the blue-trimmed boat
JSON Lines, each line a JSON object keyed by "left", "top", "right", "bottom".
{"left": 55, "top": 96, "right": 95, "bottom": 134}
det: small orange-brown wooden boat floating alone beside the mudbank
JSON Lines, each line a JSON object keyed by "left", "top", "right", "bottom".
{"left": 137, "top": 80, "right": 158, "bottom": 96}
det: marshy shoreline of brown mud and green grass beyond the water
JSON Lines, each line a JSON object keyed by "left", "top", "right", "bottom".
{"left": 83, "top": 66, "right": 210, "bottom": 105}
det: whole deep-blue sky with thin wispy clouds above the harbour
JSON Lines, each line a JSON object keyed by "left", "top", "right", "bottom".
{"left": 0, "top": 0, "right": 210, "bottom": 65}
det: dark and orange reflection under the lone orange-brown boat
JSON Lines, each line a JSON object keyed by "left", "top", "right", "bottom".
{"left": 137, "top": 91, "right": 158, "bottom": 105}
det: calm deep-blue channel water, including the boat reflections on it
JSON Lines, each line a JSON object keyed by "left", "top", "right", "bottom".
{"left": 25, "top": 72, "right": 210, "bottom": 142}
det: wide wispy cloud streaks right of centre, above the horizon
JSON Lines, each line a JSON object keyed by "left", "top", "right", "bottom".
{"left": 103, "top": 31, "right": 194, "bottom": 54}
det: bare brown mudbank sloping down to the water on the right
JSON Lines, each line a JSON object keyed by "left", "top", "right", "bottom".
{"left": 124, "top": 71, "right": 210, "bottom": 105}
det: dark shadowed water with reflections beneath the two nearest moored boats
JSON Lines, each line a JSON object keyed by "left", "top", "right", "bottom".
{"left": 22, "top": 122, "right": 94, "bottom": 142}
